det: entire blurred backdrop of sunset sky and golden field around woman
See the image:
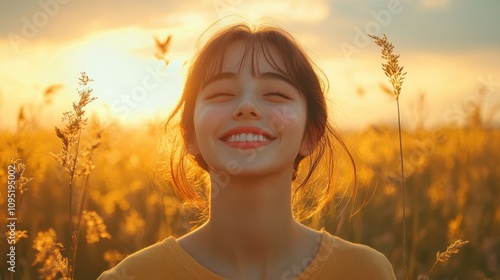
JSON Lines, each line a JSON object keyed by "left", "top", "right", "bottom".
{"left": 0, "top": 0, "right": 500, "bottom": 280}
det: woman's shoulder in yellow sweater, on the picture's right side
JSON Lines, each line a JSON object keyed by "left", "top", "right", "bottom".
{"left": 302, "top": 230, "right": 396, "bottom": 279}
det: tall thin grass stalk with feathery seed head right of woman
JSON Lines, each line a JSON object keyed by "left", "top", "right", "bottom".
{"left": 368, "top": 34, "right": 408, "bottom": 279}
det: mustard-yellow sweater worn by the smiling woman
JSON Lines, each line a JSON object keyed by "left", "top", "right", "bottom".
{"left": 98, "top": 230, "right": 396, "bottom": 280}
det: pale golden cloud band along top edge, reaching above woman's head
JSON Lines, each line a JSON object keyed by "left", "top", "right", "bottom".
{"left": 0, "top": 0, "right": 329, "bottom": 46}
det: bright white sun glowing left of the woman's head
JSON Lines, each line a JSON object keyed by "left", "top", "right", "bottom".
{"left": 64, "top": 31, "right": 186, "bottom": 124}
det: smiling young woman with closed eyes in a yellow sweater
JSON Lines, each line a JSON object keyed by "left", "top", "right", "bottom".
{"left": 96, "top": 22, "right": 395, "bottom": 279}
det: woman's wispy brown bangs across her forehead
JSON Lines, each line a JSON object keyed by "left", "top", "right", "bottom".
{"left": 198, "top": 33, "right": 298, "bottom": 90}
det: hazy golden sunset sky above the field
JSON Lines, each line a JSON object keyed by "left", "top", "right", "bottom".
{"left": 0, "top": 0, "right": 500, "bottom": 130}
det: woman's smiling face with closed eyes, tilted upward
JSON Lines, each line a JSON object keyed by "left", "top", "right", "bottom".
{"left": 189, "top": 41, "right": 307, "bottom": 176}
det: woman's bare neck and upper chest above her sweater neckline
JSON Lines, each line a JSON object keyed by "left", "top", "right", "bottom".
{"left": 179, "top": 167, "right": 321, "bottom": 279}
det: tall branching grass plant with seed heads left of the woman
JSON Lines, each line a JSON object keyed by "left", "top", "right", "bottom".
{"left": 27, "top": 72, "right": 107, "bottom": 279}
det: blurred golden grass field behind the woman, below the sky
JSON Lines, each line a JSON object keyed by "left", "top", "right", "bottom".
{"left": 0, "top": 90, "right": 500, "bottom": 279}
